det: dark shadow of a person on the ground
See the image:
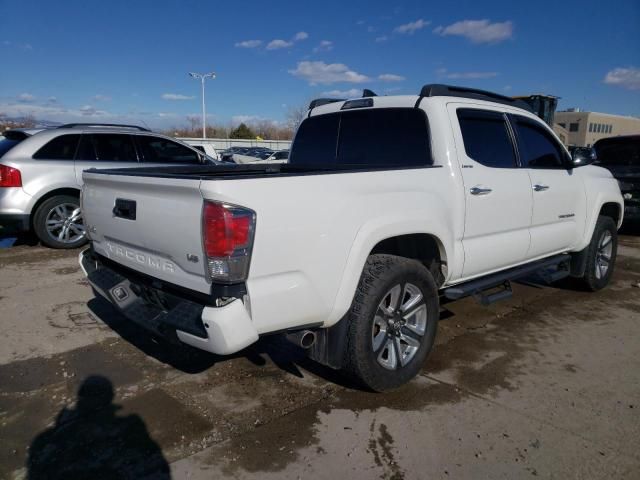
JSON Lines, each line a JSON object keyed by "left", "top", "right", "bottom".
{"left": 27, "top": 375, "right": 171, "bottom": 480}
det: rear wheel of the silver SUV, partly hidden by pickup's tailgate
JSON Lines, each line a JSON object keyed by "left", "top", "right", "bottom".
{"left": 33, "top": 195, "right": 87, "bottom": 248}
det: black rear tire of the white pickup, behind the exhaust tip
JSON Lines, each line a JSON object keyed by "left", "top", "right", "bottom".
{"left": 343, "top": 254, "right": 439, "bottom": 392}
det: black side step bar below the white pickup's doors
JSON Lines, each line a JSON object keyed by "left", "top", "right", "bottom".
{"left": 444, "top": 253, "right": 571, "bottom": 305}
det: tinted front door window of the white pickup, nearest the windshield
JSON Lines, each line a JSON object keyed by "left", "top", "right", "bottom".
{"left": 514, "top": 117, "right": 565, "bottom": 168}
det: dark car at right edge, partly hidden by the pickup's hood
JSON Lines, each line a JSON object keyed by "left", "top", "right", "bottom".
{"left": 593, "top": 135, "right": 640, "bottom": 221}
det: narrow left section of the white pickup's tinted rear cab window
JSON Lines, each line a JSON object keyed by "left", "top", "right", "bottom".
{"left": 289, "top": 113, "right": 340, "bottom": 165}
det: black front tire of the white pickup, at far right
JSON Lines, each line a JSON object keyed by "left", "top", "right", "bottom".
{"left": 580, "top": 215, "right": 618, "bottom": 292}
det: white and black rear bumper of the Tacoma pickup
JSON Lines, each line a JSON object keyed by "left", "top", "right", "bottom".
{"left": 79, "top": 249, "right": 258, "bottom": 355}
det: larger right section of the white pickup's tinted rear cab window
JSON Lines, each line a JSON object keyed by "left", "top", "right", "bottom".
{"left": 338, "top": 108, "right": 433, "bottom": 167}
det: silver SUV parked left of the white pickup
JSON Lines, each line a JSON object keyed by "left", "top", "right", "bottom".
{"left": 0, "top": 123, "right": 216, "bottom": 248}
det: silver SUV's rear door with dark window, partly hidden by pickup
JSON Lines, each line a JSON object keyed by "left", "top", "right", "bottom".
{"left": 75, "top": 133, "right": 140, "bottom": 185}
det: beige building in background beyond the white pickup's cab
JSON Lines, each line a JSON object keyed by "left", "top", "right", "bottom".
{"left": 554, "top": 110, "right": 640, "bottom": 147}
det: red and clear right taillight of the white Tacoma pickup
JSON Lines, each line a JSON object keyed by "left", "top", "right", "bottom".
{"left": 202, "top": 202, "right": 256, "bottom": 283}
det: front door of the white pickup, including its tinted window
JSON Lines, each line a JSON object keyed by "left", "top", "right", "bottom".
{"left": 510, "top": 115, "right": 587, "bottom": 259}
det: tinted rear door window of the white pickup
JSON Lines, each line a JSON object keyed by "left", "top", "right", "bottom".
{"left": 458, "top": 108, "right": 517, "bottom": 168}
